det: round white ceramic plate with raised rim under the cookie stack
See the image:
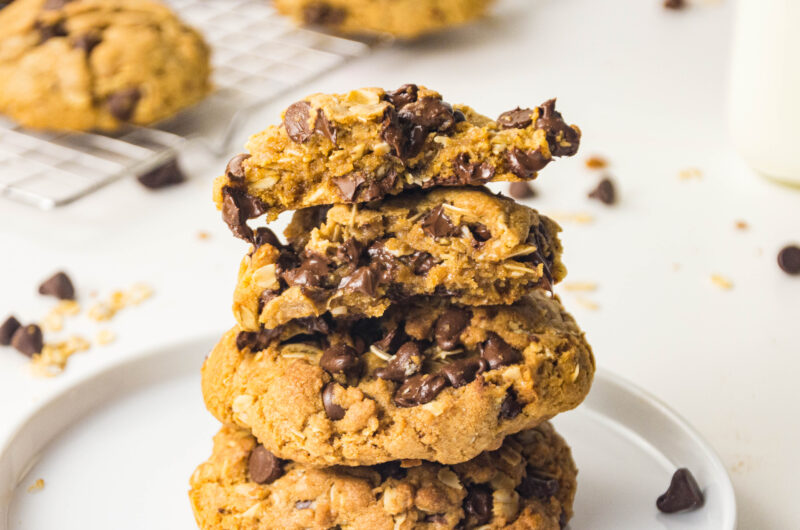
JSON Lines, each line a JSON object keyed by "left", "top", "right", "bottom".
{"left": 0, "top": 339, "right": 736, "bottom": 530}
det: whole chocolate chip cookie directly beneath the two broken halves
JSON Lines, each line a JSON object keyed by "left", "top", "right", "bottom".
{"left": 202, "top": 291, "right": 595, "bottom": 466}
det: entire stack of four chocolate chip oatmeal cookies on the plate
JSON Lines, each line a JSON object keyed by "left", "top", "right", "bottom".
{"left": 190, "top": 85, "right": 594, "bottom": 529}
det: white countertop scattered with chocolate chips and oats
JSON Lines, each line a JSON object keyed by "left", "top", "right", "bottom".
{"left": 0, "top": 0, "right": 800, "bottom": 528}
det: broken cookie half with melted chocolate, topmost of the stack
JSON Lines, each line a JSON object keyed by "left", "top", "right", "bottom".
{"left": 209, "top": 85, "right": 580, "bottom": 231}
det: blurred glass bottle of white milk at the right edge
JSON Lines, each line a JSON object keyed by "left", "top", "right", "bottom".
{"left": 730, "top": 0, "right": 800, "bottom": 186}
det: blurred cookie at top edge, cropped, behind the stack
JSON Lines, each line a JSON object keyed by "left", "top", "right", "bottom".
{"left": 274, "top": 0, "right": 492, "bottom": 39}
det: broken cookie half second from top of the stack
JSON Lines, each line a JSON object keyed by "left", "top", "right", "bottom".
{"left": 233, "top": 188, "right": 566, "bottom": 331}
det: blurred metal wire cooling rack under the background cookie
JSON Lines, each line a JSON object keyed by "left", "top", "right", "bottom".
{"left": 0, "top": 0, "right": 381, "bottom": 209}
